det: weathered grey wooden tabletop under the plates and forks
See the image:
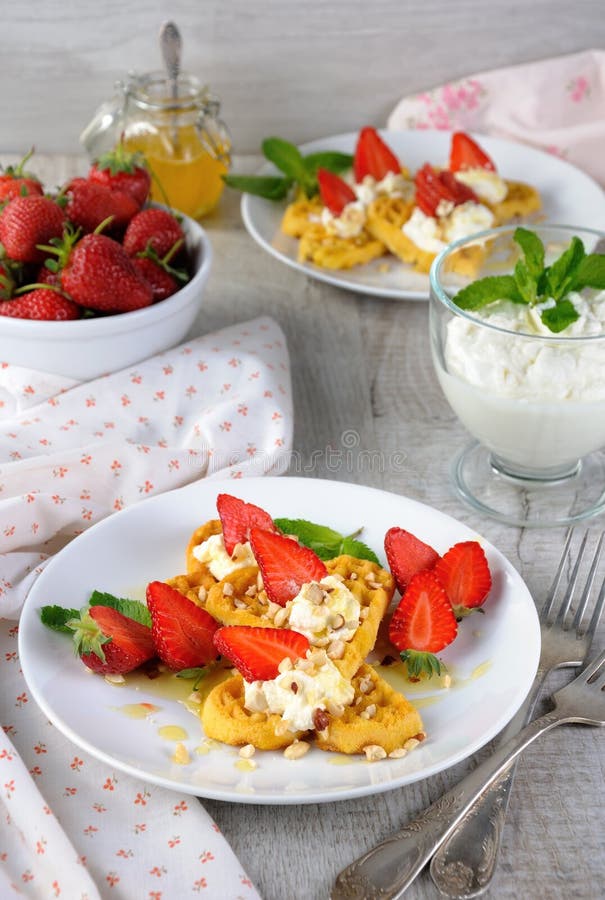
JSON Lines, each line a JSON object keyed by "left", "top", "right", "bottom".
{"left": 18, "top": 157, "right": 605, "bottom": 900}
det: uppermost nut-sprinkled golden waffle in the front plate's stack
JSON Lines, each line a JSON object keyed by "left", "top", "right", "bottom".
{"left": 206, "top": 556, "right": 395, "bottom": 679}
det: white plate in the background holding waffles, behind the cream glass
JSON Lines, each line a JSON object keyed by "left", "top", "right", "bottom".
{"left": 242, "top": 130, "right": 605, "bottom": 300}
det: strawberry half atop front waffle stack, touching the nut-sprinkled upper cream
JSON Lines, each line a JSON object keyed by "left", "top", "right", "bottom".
{"left": 250, "top": 528, "right": 328, "bottom": 606}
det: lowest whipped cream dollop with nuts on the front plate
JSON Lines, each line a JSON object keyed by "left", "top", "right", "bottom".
{"left": 244, "top": 657, "right": 355, "bottom": 732}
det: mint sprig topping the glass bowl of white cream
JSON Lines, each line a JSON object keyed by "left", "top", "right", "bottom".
{"left": 453, "top": 228, "right": 605, "bottom": 334}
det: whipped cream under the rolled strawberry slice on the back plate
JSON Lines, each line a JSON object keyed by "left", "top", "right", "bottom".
{"left": 401, "top": 201, "right": 495, "bottom": 253}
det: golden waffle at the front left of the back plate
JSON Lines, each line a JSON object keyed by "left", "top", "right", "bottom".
{"left": 298, "top": 223, "right": 386, "bottom": 269}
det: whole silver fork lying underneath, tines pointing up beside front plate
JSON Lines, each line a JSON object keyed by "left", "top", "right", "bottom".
{"left": 431, "top": 530, "right": 605, "bottom": 900}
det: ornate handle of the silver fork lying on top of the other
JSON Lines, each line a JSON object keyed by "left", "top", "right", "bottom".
{"left": 330, "top": 710, "right": 573, "bottom": 900}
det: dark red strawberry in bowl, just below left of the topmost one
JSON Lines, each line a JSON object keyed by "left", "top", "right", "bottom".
{"left": 64, "top": 178, "right": 139, "bottom": 234}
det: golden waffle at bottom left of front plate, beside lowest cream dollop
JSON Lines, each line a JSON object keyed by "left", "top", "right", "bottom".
{"left": 201, "top": 675, "right": 304, "bottom": 750}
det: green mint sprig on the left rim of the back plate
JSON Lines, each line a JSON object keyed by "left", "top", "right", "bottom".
{"left": 223, "top": 137, "right": 353, "bottom": 200}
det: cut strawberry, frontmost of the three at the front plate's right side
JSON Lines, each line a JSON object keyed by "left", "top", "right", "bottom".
{"left": 389, "top": 571, "right": 458, "bottom": 654}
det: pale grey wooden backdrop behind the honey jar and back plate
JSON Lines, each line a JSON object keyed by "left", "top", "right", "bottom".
{"left": 0, "top": 0, "right": 605, "bottom": 153}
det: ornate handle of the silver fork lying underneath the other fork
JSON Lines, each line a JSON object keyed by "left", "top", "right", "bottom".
{"left": 431, "top": 666, "right": 548, "bottom": 900}
